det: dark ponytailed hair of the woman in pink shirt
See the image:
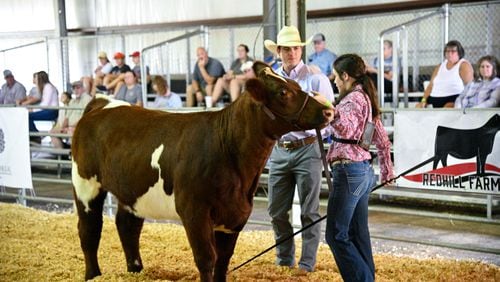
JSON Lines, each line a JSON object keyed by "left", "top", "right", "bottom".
{"left": 333, "top": 54, "right": 380, "bottom": 118}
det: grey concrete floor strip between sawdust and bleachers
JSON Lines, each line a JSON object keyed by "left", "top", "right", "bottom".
{"left": 0, "top": 174, "right": 500, "bottom": 265}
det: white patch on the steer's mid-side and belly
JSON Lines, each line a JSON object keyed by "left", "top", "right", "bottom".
{"left": 132, "top": 144, "right": 180, "bottom": 219}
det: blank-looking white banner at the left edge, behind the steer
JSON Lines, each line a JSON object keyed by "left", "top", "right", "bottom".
{"left": 0, "top": 108, "right": 33, "bottom": 189}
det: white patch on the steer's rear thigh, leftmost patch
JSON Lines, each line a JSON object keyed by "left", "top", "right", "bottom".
{"left": 71, "top": 160, "right": 101, "bottom": 212}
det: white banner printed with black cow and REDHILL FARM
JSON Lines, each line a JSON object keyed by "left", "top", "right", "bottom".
{"left": 394, "top": 109, "right": 500, "bottom": 194}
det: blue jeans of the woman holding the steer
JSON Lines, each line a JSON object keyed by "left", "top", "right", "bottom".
{"left": 325, "top": 161, "right": 375, "bottom": 281}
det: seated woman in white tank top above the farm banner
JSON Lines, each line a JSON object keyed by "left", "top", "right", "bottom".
{"left": 417, "top": 40, "right": 474, "bottom": 108}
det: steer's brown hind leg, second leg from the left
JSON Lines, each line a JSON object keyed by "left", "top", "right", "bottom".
{"left": 115, "top": 205, "right": 144, "bottom": 272}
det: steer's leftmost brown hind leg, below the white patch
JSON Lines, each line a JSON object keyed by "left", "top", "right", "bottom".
{"left": 75, "top": 191, "right": 107, "bottom": 280}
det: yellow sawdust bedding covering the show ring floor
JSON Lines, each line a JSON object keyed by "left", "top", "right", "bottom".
{"left": 0, "top": 203, "right": 500, "bottom": 281}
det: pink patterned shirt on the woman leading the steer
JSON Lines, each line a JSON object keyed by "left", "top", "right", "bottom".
{"left": 326, "top": 85, "right": 394, "bottom": 181}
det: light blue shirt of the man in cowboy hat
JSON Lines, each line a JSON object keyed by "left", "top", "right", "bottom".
{"left": 276, "top": 61, "right": 334, "bottom": 141}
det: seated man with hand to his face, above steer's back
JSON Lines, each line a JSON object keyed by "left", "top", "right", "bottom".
{"left": 186, "top": 47, "right": 226, "bottom": 107}
